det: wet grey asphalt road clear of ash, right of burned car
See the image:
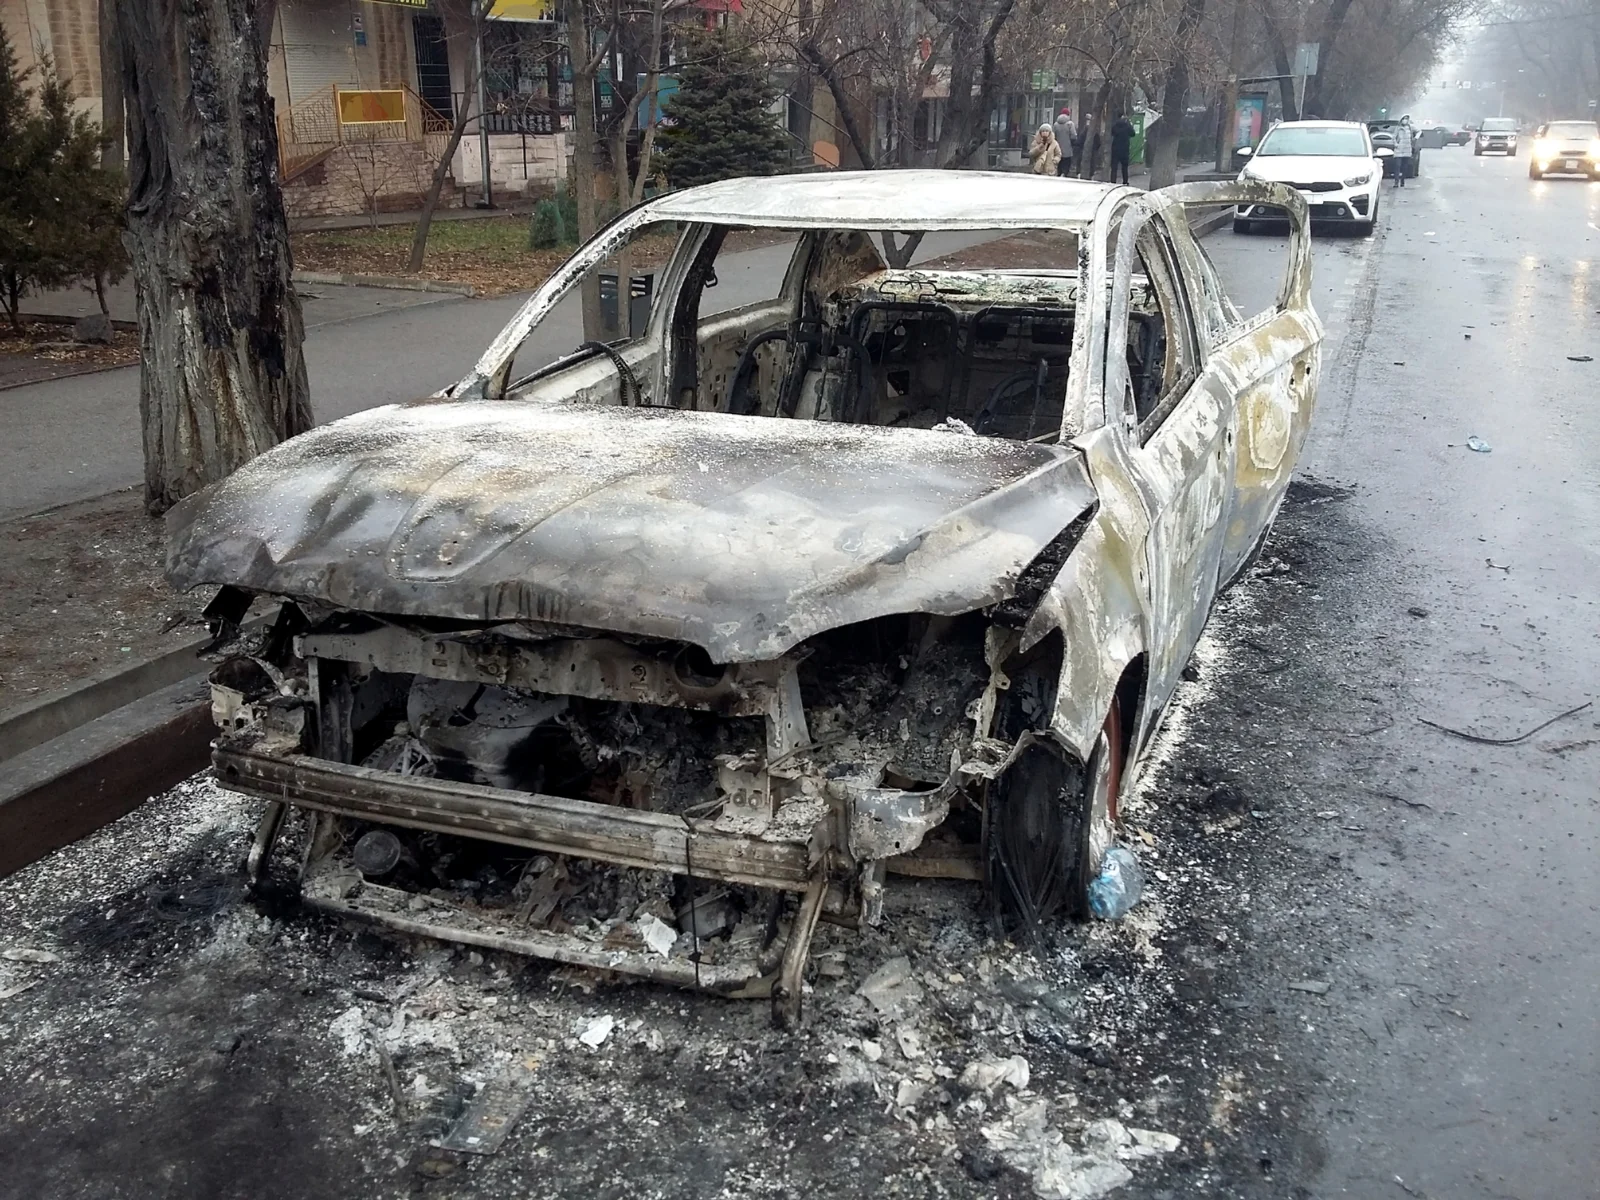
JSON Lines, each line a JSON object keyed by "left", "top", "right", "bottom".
{"left": 1294, "top": 149, "right": 1600, "bottom": 1200}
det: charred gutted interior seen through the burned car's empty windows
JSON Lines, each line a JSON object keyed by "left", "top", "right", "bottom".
{"left": 507, "top": 226, "right": 1176, "bottom": 440}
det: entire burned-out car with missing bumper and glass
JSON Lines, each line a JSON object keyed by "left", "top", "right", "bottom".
{"left": 168, "top": 171, "right": 1322, "bottom": 1019}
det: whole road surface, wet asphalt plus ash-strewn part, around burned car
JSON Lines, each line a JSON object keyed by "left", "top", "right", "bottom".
{"left": 0, "top": 160, "right": 1600, "bottom": 1200}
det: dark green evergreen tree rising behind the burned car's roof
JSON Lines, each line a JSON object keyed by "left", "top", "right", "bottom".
{"left": 658, "top": 29, "right": 784, "bottom": 187}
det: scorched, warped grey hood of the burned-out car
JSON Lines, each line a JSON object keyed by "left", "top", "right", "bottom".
{"left": 168, "top": 400, "right": 1094, "bottom": 662}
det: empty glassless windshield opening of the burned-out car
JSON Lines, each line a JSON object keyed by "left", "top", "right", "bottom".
{"left": 510, "top": 226, "right": 1100, "bottom": 442}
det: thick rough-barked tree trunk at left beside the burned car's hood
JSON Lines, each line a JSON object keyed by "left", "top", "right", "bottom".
{"left": 117, "top": 0, "right": 312, "bottom": 514}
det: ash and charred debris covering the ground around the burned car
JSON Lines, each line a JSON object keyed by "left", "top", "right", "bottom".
{"left": 0, "top": 483, "right": 1369, "bottom": 1200}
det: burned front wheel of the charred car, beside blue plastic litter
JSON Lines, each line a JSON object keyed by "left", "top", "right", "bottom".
{"left": 987, "top": 706, "right": 1123, "bottom": 934}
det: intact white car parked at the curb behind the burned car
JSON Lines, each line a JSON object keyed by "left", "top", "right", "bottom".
{"left": 1234, "top": 122, "right": 1394, "bottom": 237}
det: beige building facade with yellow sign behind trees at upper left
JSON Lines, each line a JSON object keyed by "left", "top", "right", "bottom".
{"left": 0, "top": 0, "right": 571, "bottom": 216}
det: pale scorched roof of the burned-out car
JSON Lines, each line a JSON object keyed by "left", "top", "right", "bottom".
{"left": 648, "top": 170, "right": 1122, "bottom": 230}
